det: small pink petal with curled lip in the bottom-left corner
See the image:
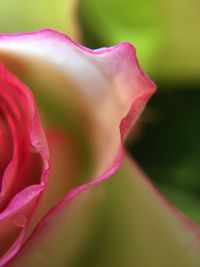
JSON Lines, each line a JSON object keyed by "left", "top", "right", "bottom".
{"left": 0, "top": 185, "right": 44, "bottom": 266}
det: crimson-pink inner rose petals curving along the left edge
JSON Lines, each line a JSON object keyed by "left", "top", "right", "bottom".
{"left": 0, "top": 65, "right": 49, "bottom": 266}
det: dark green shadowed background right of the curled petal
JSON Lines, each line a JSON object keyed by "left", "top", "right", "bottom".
{"left": 129, "top": 87, "right": 200, "bottom": 224}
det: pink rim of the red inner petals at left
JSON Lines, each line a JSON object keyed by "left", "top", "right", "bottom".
{"left": 0, "top": 66, "right": 50, "bottom": 267}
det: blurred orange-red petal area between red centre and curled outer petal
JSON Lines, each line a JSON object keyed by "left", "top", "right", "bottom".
{"left": 24, "top": 130, "right": 78, "bottom": 240}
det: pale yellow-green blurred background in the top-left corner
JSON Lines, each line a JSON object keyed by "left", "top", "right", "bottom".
{"left": 0, "top": 0, "right": 79, "bottom": 39}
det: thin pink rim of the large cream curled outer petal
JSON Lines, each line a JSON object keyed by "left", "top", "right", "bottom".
{"left": 0, "top": 29, "right": 156, "bottom": 262}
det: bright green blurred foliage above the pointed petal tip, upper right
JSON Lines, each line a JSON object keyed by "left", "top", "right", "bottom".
{"left": 80, "top": 0, "right": 200, "bottom": 82}
